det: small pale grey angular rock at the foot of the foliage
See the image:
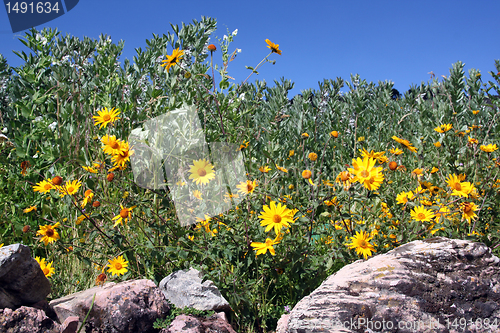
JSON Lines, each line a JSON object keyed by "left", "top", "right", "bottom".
{"left": 158, "top": 268, "right": 231, "bottom": 312}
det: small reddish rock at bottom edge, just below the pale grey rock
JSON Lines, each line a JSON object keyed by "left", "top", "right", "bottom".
{"left": 160, "top": 312, "right": 236, "bottom": 333}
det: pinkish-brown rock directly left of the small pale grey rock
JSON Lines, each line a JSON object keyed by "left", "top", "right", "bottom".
{"left": 49, "top": 279, "right": 170, "bottom": 333}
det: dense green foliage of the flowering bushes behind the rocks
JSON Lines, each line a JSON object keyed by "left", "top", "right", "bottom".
{"left": 0, "top": 18, "right": 500, "bottom": 332}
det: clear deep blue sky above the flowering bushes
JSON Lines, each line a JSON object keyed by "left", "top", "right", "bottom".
{"left": 0, "top": 0, "right": 500, "bottom": 98}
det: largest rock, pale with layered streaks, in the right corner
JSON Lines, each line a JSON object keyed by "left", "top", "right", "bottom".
{"left": 280, "top": 237, "right": 500, "bottom": 333}
